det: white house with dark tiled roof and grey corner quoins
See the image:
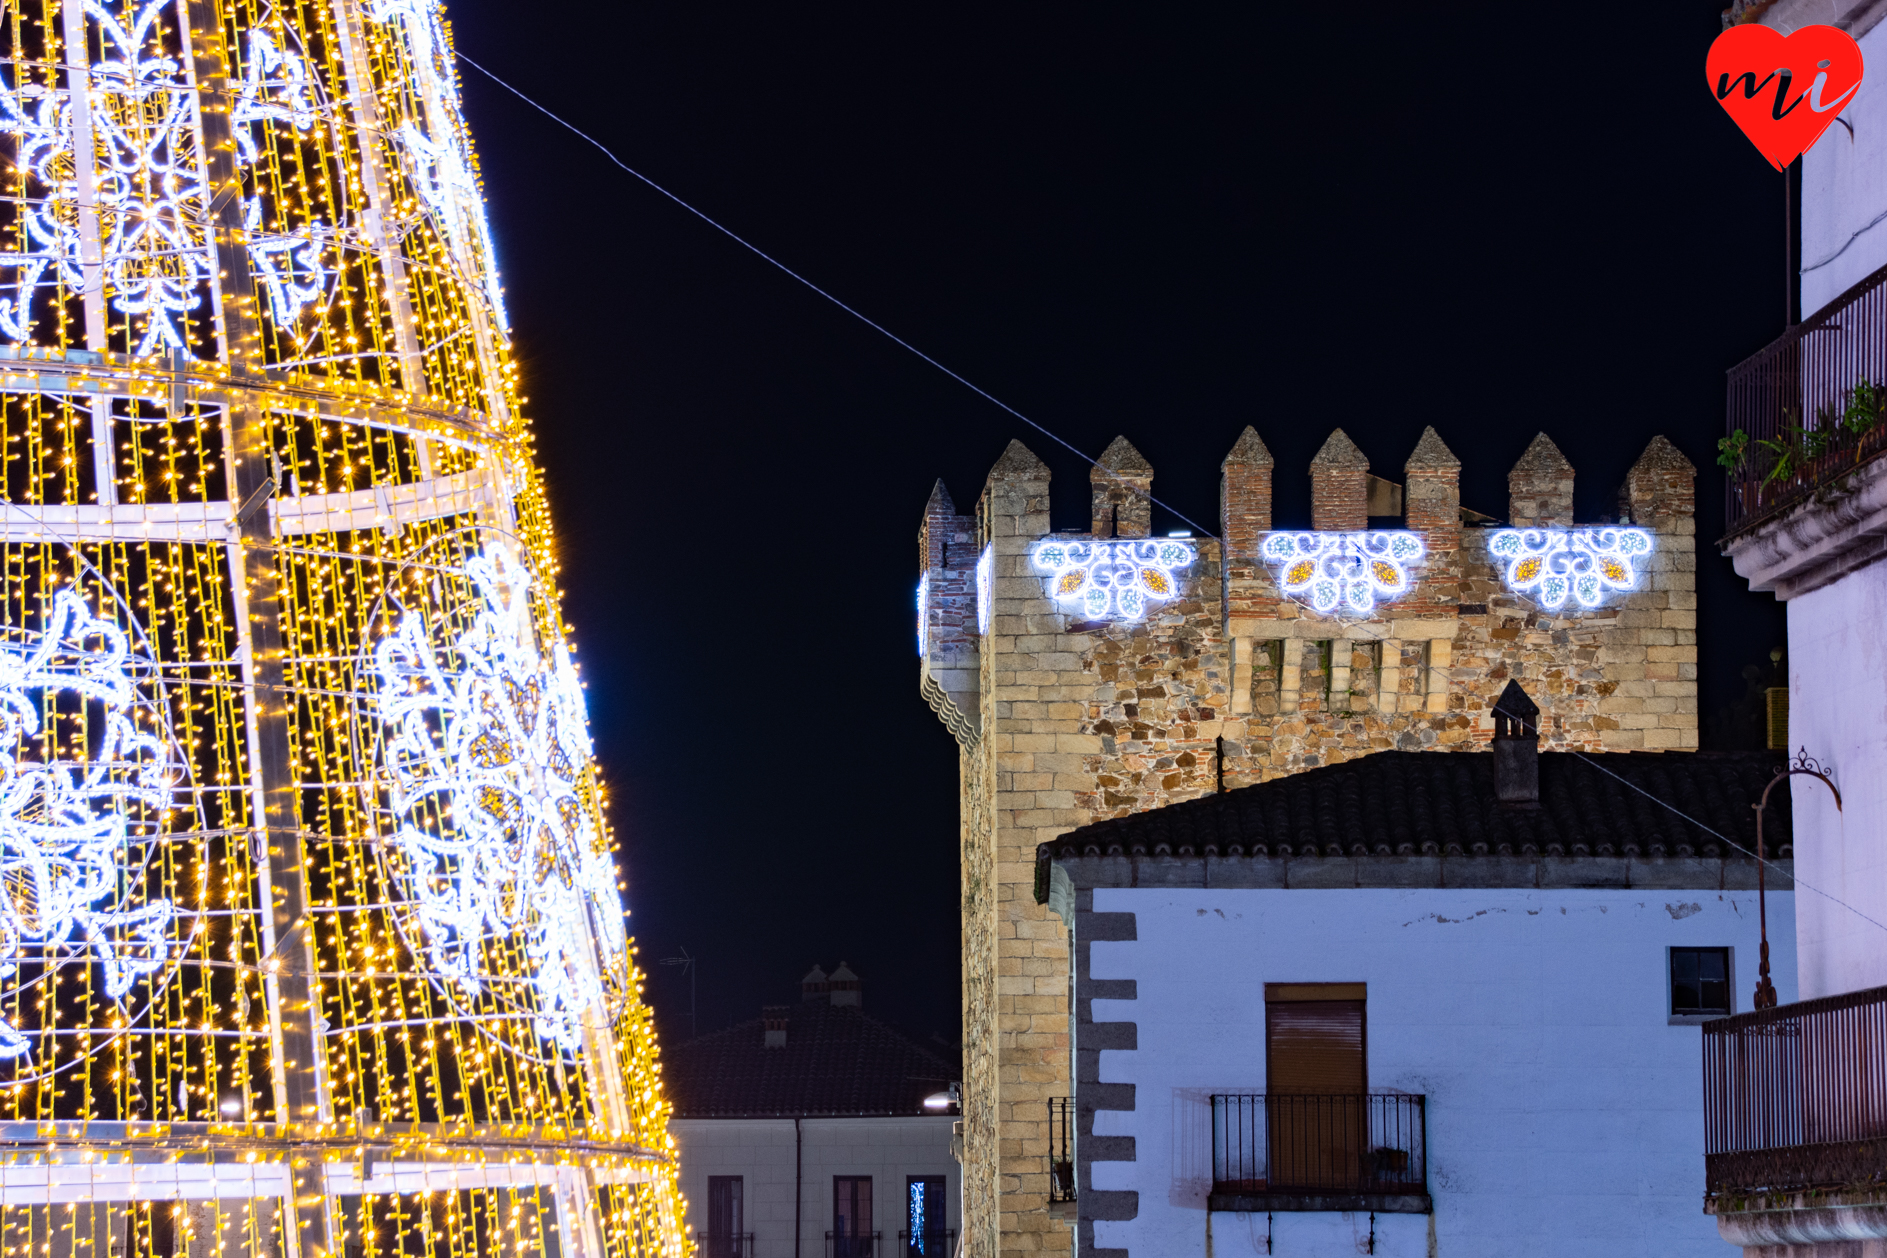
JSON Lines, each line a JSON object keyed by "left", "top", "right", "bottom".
{"left": 1036, "top": 685, "right": 1795, "bottom": 1258}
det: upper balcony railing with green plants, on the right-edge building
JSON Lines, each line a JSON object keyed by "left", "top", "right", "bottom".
{"left": 1719, "top": 256, "right": 1887, "bottom": 534}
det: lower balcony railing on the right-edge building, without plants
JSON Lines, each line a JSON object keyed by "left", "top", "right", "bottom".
{"left": 1704, "top": 986, "right": 1887, "bottom": 1192}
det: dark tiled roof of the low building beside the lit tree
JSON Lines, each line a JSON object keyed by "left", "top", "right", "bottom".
{"left": 662, "top": 1001, "right": 962, "bottom": 1118}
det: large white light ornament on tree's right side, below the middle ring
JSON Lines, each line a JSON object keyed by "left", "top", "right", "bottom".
{"left": 374, "top": 545, "right": 626, "bottom": 1052}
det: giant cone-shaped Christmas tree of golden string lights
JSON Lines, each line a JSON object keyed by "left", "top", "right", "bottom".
{"left": 0, "top": 0, "right": 683, "bottom": 1258}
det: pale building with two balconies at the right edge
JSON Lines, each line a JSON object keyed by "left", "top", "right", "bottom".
{"left": 1704, "top": 0, "right": 1887, "bottom": 1258}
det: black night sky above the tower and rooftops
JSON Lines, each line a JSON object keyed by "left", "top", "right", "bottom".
{"left": 449, "top": 0, "right": 1796, "bottom": 1041}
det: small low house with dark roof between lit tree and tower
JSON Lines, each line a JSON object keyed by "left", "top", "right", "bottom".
{"left": 662, "top": 962, "right": 962, "bottom": 1258}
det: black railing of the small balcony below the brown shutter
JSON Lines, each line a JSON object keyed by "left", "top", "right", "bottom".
{"left": 1211, "top": 1092, "right": 1428, "bottom": 1196}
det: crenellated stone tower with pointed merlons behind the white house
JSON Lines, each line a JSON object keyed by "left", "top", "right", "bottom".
{"left": 919, "top": 428, "right": 1696, "bottom": 1258}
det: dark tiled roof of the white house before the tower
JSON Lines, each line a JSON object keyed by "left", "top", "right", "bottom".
{"left": 1038, "top": 751, "right": 1793, "bottom": 860}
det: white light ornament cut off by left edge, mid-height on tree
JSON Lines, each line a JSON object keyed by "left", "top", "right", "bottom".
{"left": 0, "top": 590, "right": 175, "bottom": 1058}
